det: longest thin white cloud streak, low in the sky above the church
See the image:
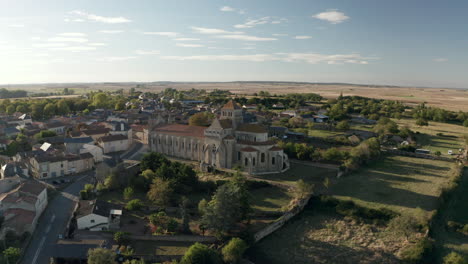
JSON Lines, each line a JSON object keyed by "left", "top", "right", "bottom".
{"left": 161, "top": 53, "right": 378, "bottom": 64}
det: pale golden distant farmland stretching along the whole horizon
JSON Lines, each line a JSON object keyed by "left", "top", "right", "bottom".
{"left": 0, "top": 82, "right": 468, "bottom": 112}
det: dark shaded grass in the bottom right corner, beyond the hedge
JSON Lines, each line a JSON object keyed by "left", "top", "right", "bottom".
{"left": 434, "top": 168, "right": 468, "bottom": 257}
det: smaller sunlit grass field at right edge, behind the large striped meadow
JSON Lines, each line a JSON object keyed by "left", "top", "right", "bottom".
{"left": 395, "top": 119, "right": 468, "bottom": 156}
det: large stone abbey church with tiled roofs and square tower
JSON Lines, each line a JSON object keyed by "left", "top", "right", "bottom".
{"left": 148, "top": 101, "right": 289, "bottom": 174}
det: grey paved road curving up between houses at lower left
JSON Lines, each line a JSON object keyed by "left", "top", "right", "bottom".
{"left": 21, "top": 171, "right": 94, "bottom": 264}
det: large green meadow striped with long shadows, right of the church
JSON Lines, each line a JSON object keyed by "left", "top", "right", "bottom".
{"left": 330, "top": 156, "right": 454, "bottom": 218}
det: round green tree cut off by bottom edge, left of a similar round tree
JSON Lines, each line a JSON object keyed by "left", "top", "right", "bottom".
{"left": 180, "top": 242, "right": 221, "bottom": 264}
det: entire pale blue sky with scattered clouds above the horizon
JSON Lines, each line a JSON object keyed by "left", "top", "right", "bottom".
{"left": 0, "top": 0, "right": 468, "bottom": 88}
